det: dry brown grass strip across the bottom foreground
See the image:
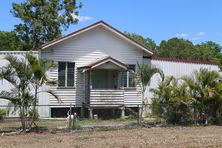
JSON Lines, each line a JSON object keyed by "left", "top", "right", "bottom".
{"left": 0, "top": 126, "right": 222, "bottom": 148}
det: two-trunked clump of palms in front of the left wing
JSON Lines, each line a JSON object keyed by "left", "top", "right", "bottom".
{"left": 0, "top": 53, "right": 60, "bottom": 131}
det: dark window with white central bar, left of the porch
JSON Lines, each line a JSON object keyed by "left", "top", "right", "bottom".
{"left": 58, "top": 62, "right": 75, "bottom": 87}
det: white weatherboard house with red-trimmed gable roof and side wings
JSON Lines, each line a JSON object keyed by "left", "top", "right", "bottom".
{"left": 0, "top": 21, "right": 219, "bottom": 118}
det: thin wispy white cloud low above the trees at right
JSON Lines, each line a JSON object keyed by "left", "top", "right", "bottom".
{"left": 176, "top": 31, "right": 206, "bottom": 41}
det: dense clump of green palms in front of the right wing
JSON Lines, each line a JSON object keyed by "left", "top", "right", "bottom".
{"left": 151, "top": 69, "right": 222, "bottom": 124}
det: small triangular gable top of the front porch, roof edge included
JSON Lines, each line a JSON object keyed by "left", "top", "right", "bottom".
{"left": 78, "top": 56, "right": 128, "bottom": 70}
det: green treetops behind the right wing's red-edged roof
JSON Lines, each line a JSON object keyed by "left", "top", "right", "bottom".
{"left": 155, "top": 38, "right": 222, "bottom": 62}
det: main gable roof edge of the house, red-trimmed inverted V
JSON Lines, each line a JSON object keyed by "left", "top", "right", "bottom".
{"left": 40, "top": 21, "right": 153, "bottom": 54}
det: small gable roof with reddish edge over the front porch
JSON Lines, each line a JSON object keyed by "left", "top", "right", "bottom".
{"left": 78, "top": 56, "right": 128, "bottom": 70}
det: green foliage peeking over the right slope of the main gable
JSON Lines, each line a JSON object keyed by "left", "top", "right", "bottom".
{"left": 125, "top": 32, "right": 157, "bottom": 50}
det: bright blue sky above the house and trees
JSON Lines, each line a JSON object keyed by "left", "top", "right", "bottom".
{"left": 0, "top": 0, "right": 222, "bottom": 45}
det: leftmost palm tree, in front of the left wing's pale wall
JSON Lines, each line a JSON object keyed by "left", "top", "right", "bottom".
{"left": 0, "top": 55, "right": 34, "bottom": 132}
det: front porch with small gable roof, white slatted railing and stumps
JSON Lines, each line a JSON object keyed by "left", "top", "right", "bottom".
{"left": 79, "top": 57, "right": 142, "bottom": 119}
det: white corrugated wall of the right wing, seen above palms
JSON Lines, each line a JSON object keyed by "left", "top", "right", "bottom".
{"left": 144, "top": 59, "right": 219, "bottom": 103}
